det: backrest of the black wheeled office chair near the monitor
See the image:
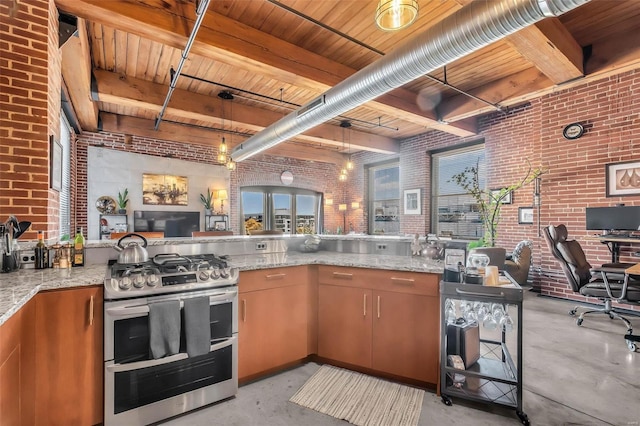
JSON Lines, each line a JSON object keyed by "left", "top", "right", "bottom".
{"left": 544, "top": 225, "right": 591, "bottom": 292}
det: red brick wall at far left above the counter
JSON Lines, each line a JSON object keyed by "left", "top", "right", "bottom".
{"left": 0, "top": 0, "right": 60, "bottom": 239}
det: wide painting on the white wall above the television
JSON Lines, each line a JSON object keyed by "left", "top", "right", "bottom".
{"left": 142, "top": 173, "right": 189, "bottom": 206}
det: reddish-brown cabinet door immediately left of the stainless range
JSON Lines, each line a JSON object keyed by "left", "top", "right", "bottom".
{"left": 35, "top": 287, "right": 104, "bottom": 425}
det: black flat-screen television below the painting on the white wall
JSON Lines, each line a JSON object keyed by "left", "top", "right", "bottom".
{"left": 133, "top": 210, "right": 200, "bottom": 238}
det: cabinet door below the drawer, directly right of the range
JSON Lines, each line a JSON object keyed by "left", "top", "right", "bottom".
{"left": 238, "top": 284, "right": 309, "bottom": 378}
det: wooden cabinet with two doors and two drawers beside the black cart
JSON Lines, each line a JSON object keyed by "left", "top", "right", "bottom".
{"left": 318, "top": 266, "right": 440, "bottom": 384}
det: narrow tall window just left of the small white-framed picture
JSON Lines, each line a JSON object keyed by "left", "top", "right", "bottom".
{"left": 369, "top": 161, "right": 400, "bottom": 235}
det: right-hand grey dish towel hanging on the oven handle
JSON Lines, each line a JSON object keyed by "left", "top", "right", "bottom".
{"left": 184, "top": 296, "right": 211, "bottom": 357}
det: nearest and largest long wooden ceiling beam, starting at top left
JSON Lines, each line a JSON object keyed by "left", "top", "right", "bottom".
{"left": 56, "top": 0, "right": 474, "bottom": 136}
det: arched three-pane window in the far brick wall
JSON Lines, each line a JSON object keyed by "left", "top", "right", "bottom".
{"left": 240, "top": 186, "right": 322, "bottom": 234}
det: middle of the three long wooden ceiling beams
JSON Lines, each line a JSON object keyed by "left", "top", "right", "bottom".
{"left": 94, "top": 70, "right": 400, "bottom": 154}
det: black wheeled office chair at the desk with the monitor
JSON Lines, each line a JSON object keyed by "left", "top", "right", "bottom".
{"left": 544, "top": 225, "right": 640, "bottom": 351}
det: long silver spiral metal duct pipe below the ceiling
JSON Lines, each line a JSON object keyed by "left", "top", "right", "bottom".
{"left": 231, "top": 0, "right": 590, "bottom": 161}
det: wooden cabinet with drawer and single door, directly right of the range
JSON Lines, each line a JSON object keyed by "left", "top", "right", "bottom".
{"left": 238, "top": 266, "right": 309, "bottom": 379}
